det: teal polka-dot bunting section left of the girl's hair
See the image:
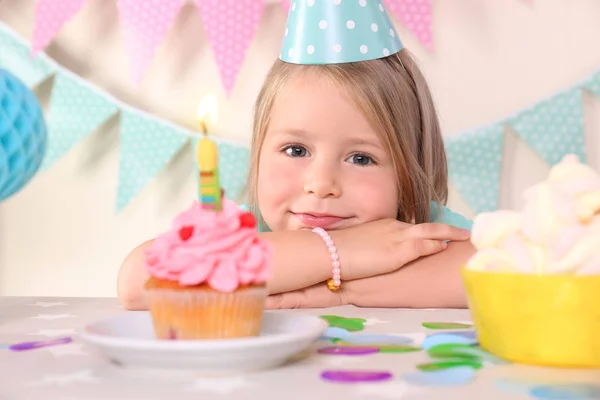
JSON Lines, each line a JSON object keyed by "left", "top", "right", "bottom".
{"left": 0, "top": 23, "right": 249, "bottom": 211}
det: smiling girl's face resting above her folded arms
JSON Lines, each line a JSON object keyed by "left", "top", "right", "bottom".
{"left": 257, "top": 74, "right": 398, "bottom": 231}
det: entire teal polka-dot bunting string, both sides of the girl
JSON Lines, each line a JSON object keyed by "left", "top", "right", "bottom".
{"left": 0, "top": 24, "right": 600, "bottom": 212}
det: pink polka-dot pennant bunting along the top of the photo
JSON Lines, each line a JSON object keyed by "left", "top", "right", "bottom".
{"left": 31, "top": 0, "right": 528, "bottom": 96}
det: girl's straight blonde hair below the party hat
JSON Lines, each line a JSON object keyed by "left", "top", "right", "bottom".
{"left": 247, "top": 50, "right": 448, "bottom": 223}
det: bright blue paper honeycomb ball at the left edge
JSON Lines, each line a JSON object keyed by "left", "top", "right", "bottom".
{"left": 0, "top": 68, "right": 47, "bottom": 201}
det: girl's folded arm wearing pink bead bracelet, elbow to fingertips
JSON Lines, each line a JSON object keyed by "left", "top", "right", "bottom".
{"left": 118, "top": 219, "right": 469, "bottom": 310}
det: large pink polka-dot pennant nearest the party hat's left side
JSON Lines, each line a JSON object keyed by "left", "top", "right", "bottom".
{"left": 196, "top": 0, "right": 264, "bottom": 96}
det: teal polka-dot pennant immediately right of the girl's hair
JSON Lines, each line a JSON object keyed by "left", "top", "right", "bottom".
{"left": 445, "top": 123, "right": 504, "bottom": 213}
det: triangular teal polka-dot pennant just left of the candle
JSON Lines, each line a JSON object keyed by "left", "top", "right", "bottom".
{"left": 117, "top": 110, "right": 188, "bottom": 211}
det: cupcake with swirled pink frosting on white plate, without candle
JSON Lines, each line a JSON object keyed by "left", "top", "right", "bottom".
{"left": 145, "top": 199, "right": 272, "bottom": 340}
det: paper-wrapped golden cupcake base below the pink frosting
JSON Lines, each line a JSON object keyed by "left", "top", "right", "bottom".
{"left": 146, "top": 287, "right": 267, "bottom": 340}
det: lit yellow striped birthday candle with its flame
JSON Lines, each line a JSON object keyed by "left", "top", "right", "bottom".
{"left": 196, "top": 96, "right": 222, "bottom": 211}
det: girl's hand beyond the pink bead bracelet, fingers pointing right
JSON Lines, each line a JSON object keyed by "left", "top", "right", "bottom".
{"left": 329, "top": 218, "right": 470, "bottom": 281}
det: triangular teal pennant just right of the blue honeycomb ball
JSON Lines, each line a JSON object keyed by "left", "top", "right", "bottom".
{"left": 42, "top": 71, "right": 118, "bottom": 169}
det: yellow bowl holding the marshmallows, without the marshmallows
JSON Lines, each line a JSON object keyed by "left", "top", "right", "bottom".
{"left": 462, "top": 268, "right": 600, "bottom": 368}
